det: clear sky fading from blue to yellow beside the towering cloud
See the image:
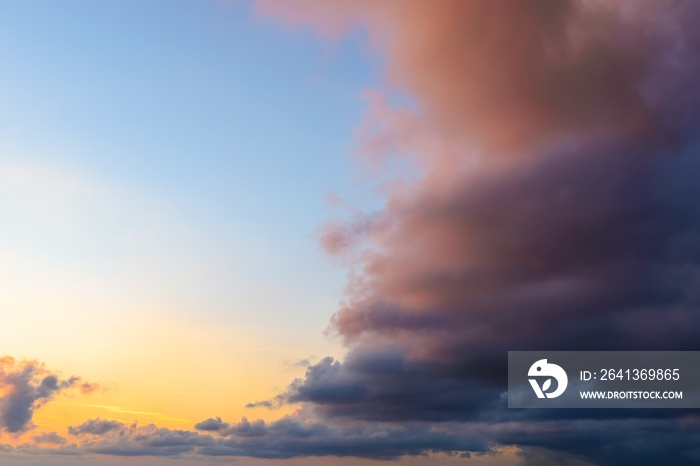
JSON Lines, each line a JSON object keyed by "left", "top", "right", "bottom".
{"left": 0, "top": 1, "right": 375, "bottom": 425}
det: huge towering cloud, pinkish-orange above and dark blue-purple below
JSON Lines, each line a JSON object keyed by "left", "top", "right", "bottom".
{"left": 251, "top": 0, "right": 700, "bottom": 464}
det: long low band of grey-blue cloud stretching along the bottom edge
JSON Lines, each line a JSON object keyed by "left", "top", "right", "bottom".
{"left": 50, "top": 409, "right": 700, "bottom": 466}
